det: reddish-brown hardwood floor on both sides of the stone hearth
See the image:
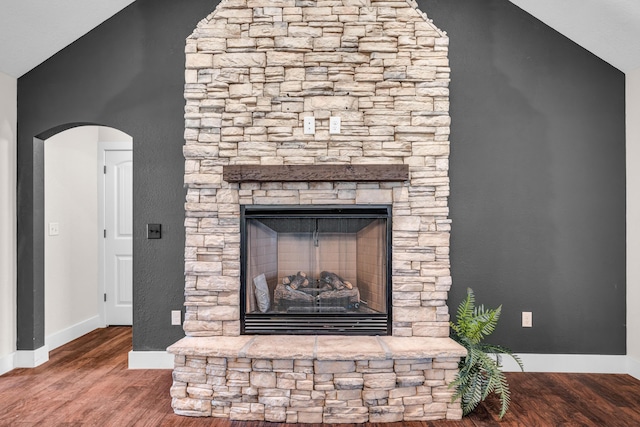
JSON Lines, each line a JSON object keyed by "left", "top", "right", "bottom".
{"left": 0, "top": 327, "right": 640, "bottom": 427}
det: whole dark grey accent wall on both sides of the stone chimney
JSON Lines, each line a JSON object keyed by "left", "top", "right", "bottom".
{"left": 18, "top": 0, "right": 625, "bottom": 354}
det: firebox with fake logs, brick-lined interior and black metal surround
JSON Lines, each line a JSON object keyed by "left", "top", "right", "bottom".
{"left": 240, "top": 205, "right": 391, "bottom": 335}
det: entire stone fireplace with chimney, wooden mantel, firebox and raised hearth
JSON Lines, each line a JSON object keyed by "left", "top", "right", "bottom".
{"left": 168, "top": 0, "right": 465, "bottom": 423}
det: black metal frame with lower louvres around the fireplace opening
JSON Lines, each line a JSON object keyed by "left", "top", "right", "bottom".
{"left": 240, "top": 205, "right": 393, "bottom": 335}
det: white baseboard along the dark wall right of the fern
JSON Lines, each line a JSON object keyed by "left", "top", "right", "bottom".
{"left": 502, "top": 354, "right": 628, "bottom": 376}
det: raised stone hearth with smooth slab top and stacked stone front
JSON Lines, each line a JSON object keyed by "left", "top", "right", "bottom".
{"left": 169, "top": 336, "right": 464, "bottom": 423}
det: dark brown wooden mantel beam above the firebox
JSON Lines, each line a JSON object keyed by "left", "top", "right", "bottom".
{"left": 222, "top": 165, "right": 409, "bottom": 182}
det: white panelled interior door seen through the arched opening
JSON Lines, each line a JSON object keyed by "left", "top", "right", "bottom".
{"left": 104, "top": 150, "right": 133, "bottom": 325}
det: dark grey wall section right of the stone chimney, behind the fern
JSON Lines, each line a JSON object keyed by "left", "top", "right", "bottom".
{"left": 424, "top": 0, "right": 626, "bottom": 354}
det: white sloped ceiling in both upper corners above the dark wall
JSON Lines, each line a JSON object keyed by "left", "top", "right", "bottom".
{"left": 0, "top": 0, "right": 640, "bottom": 78}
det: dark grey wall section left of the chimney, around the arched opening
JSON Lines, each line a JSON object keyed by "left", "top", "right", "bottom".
{"left": 18, "top": 0, "right": 217, "bottom": 350}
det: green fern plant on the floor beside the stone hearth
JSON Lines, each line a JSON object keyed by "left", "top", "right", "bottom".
{"left": 450, "top": 288, "right": 524, "bottom": 418}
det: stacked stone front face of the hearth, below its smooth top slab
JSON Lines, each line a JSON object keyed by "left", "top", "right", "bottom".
{"left": 171, "top": 356, "right": 462, "bottom": 423}
